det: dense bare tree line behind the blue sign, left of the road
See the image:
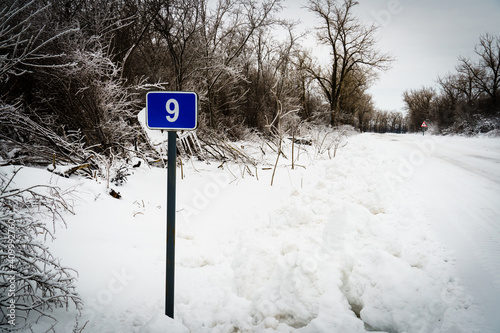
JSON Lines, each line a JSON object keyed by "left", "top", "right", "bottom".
{"left": 0, "top": 0, "right": 393, "bottom": 163}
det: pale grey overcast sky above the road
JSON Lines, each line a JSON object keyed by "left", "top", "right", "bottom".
{"left": 284, "top": 0, "right": 500, "bottom": 111}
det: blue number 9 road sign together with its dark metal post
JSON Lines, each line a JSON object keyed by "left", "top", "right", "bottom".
{"left": 146, "top": 91, "right": 198, "bottom": 319}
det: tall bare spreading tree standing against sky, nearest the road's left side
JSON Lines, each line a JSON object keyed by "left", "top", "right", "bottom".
{"left": 307, "top": 0, "right": 392, "bottom": 125}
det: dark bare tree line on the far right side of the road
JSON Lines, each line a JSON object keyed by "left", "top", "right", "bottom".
{"left": 403, "top": 34, "right": 500, "bottom": 134}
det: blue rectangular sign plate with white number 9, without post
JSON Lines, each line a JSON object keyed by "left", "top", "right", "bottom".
{"left": 146, "top": 91, "right": 198, "bottom": 131}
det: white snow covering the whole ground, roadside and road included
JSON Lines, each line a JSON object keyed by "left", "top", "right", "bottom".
{"left": 2, "top": 134, "right": 500, "bottom": 333}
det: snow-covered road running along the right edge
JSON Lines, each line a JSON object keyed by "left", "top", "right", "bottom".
{"left": 378, "top": 136, "right": 500, "bottom": 332}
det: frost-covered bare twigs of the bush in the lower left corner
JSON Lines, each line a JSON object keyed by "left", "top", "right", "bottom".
{"left": 0, "top": 169, "right": 82, "bottom": 329}
